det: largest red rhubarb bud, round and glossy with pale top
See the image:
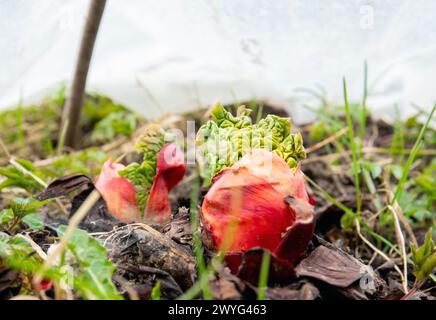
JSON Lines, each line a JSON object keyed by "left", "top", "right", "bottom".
{"left": 201, "top": 149, "right": 314, "bottom": 272}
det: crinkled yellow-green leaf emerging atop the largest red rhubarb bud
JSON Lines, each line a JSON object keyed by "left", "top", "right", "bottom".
{"left": 196, "top": 104, "right": 306, "bottom": 185}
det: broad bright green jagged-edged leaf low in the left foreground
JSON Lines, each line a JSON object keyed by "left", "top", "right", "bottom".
{"left": 58, "top": 226, "right": 122, "bottom": 300}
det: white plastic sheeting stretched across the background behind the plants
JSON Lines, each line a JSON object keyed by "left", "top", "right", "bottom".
{"left": 0, "top": 0, "right": 436, "bottom": 122}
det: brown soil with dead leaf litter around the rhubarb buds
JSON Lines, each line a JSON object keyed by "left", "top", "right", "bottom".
{"left": 0, "top": 102, "right": 436, "bottom": 300}
